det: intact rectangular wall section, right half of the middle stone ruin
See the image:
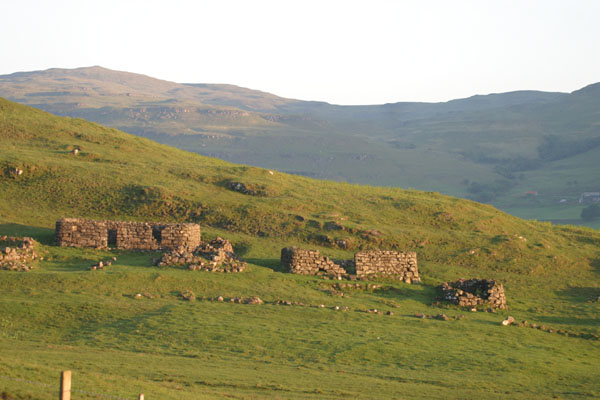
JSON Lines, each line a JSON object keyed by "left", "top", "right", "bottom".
{"left": 354, "top": 250, "right": 421, "bottom": 283}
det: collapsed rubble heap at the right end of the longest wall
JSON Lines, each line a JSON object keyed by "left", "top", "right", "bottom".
{"left": 156, "top": 237, "right": 246, "bottom": 272}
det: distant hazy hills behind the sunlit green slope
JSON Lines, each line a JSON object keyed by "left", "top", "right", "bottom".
{"left": 0, "top": 67, "right": 600, "bottom": 228}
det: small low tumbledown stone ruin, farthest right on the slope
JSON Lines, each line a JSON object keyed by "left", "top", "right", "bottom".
{"left": 440, "top": 279, "right": 506, "bottom": 308}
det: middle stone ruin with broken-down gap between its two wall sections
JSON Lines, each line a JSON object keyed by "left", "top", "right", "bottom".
{"left": 281, "top": 247, "right": 420, "bottom": 283}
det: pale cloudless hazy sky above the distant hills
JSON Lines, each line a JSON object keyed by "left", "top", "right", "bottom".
{"left": 0, "top": 0, "right": 600, "bottom": 104}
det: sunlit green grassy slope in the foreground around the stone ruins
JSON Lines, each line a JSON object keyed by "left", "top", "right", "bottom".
{"left": 0, "top": 100, "right": 600, "bottom": 399}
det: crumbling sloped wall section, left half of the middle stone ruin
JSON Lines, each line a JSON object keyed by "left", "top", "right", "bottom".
{"left": 281, "top": 247, "right": 347, "bottom": 277}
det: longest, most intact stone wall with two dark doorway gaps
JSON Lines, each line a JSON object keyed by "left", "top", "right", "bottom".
{"left": 55, "top": 218, "right": 201, "bottom": 250}
